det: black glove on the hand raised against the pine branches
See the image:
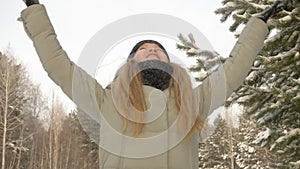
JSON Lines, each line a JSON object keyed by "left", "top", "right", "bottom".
{"left": 256, "top": 0, "right": 283, "bottom": 22}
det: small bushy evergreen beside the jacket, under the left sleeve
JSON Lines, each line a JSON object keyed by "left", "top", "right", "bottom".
{"left": 61, "top": 110, "right": 99, "bottom": 169}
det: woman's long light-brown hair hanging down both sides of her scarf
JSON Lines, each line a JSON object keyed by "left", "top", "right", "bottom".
{"left": 112, "top": 59, "right": 204, "bottom": 136}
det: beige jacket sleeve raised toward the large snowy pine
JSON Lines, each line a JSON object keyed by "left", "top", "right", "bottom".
{"left": 197, "top": 17, "right": 269, "bottom": 119}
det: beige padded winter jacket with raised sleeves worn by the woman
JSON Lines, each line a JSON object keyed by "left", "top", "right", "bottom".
{"left": 19, "top": 5, "right": 268, "bottom": 169}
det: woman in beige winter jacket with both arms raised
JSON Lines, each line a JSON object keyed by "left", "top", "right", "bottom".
{"left": 20, "top": 0, "right": 282, "bottom": 169}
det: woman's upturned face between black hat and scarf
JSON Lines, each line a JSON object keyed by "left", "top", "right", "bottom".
{"left": 133, "top": 43, "right": 169, "bottom": 63}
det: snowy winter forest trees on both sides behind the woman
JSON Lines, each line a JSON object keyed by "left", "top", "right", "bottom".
{"left": 0, "top": 0, "right": 300, "bottom": 169}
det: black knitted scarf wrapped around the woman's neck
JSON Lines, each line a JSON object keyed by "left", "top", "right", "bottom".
{"left": 138, "top": 60, "right": 173, "bottom": 90}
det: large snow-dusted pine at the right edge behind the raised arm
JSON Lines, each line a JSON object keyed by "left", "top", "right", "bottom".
{"left": 215, "top": 0, "right": 300, "bottom": 168}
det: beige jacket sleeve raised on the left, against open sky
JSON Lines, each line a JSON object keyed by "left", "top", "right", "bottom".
{"left": 18, "top": 5, "right": 105, "bottom": 119}
